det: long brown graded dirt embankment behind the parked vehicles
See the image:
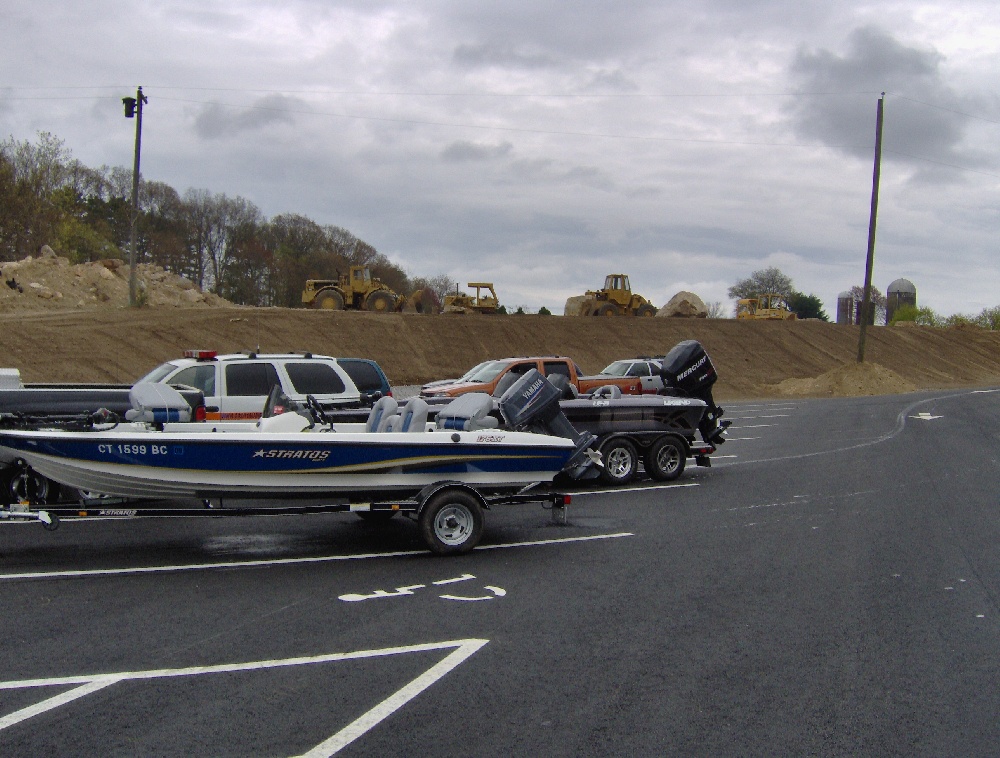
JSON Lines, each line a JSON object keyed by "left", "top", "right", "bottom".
{"left": 0, "top": 307, "right": 1000, "bottom": 400}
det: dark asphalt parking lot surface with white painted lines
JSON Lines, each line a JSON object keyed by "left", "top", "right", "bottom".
{"left": 0, "top": 391, "right": 1000, "bottom": 756}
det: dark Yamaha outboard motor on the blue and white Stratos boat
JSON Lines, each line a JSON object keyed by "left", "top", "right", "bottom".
{"left": 498, "top": 369, "right": 600, "bottom": 479}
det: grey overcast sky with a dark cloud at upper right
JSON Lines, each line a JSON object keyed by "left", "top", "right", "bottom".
{"left": 0, "top": 0, "right": 1000, "bottom": 319}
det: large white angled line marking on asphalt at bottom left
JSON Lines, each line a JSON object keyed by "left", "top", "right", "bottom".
{"left": 0, "top": 639, "right": 489, "bottom": 758}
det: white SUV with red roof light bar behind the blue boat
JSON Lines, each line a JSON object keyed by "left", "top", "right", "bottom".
{"left": 139, "top": 350, "right": 361, "bottom": 421}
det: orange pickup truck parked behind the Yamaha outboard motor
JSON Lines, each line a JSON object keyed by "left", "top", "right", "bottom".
{"left": 420, "top": 355, "right": 642, "bottom": 398}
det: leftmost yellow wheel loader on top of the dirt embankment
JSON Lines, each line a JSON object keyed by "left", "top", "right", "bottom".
{"left": 302, "top": 266, "right": 440, "bottom": 313}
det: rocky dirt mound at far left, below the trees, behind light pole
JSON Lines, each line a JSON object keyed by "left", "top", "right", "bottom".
{"left": 0, "top": 247, "right": 232, "bottom": 312}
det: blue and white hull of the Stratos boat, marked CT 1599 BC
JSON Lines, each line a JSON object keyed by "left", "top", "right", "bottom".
{"left": 0, "top": 430, "right": 574, "bottom": 498}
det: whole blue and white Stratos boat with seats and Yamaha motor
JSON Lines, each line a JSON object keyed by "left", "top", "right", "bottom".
{"left": 0, "top": 372, "right": 593, "bottom": 499}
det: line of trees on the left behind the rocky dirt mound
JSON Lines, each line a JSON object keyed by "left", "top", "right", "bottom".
{"left": 0, "top": 132, "right": 453, "bottom": 307}
